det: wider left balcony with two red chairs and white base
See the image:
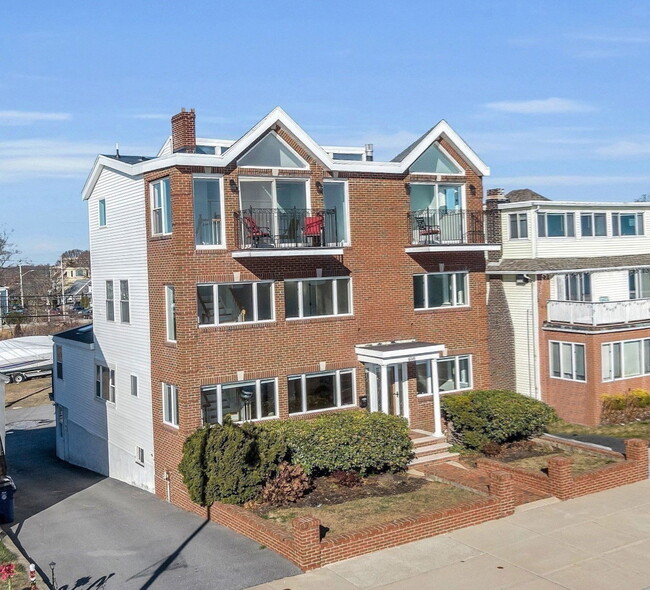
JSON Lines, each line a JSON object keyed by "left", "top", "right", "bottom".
{"left": 232, "top": 207, "right": 343, "bottom": 258}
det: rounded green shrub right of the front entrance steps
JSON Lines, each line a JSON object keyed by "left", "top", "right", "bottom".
{"left": 441, "top": 390, "right": 557, "bottom": 450}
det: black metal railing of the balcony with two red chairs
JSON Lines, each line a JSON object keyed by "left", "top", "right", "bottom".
{"left": 235, "top": 207, "right": 340, "bottom": 248}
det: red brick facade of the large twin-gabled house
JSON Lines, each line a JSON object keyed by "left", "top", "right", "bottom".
{"left": 143, "top": 121, "right": 489, "bottom": 509}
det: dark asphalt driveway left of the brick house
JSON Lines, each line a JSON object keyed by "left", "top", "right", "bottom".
{"left": 6, "top": 406, "right": 299, "bottom": 590}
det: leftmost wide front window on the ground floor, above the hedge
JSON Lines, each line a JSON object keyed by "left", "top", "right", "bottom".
{"left": 201, "top": 379, "right": 278, "bottom": 424}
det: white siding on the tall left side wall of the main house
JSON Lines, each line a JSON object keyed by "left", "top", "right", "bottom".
{"left": 88, "top": 169, "right": 154, "bottom": 492}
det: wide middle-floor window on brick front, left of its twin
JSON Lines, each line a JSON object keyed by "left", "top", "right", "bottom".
{"left": 197, "top": 281, "right": 275, "bottom": 326}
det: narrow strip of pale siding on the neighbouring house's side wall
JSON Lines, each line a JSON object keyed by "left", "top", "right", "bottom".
{"left": 503, "top": 275, "right": 538, "bottom": 397}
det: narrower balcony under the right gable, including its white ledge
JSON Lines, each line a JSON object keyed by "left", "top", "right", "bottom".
{"left": 406, "top": 208, "right": 501, "bottom": 253}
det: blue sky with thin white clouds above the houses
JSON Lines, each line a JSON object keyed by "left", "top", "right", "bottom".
{"left": 0, "top": 0, "right": 650, "bottom": 263}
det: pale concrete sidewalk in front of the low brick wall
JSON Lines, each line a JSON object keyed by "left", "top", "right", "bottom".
{"left": 255, "top": 481, "right": 650, "bottom": 590}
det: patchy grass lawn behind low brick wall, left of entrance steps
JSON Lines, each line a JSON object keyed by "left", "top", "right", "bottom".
{"left": 262, "top": 480, "right": 478, "bottom": 537}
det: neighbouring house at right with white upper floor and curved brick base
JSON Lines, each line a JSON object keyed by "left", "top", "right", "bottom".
{"left": 487, "top": 189, "right": 650, "bottom": 425}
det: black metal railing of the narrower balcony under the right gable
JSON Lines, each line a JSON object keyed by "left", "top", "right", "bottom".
{"left": 408, "top": 208, "right": 496, "bottom": 245}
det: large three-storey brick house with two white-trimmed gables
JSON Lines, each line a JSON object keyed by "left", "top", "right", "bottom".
{"left": 55, "top": 108, "right": 499, "bottom": 507}
